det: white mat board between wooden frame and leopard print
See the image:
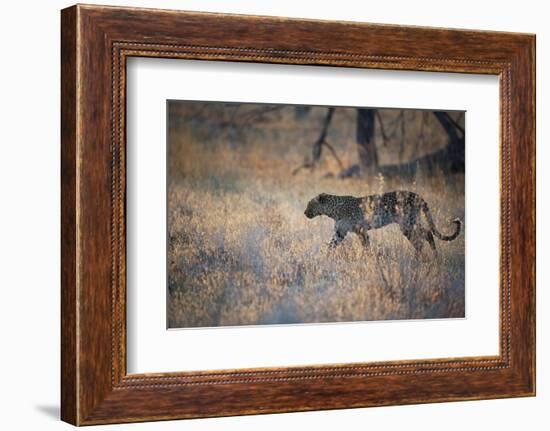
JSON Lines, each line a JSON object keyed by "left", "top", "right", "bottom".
{"left": 127, "top": 58, "right": 500, "bottom": 373}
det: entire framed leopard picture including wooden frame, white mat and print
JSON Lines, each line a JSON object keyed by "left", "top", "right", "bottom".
{"left": 61, "top": 5, "right": 535, "bottom": 425}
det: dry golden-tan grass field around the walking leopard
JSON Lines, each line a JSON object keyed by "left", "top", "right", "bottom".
{"left": 167, "top": 104, "right": 464, "bottom": 328}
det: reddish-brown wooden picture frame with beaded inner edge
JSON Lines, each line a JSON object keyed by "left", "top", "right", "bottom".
{"left": 61, "top": 5, "right": 535, "bottom": 425}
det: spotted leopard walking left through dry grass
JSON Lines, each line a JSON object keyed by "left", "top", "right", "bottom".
{"left": 304, "top": 190, "right": 462, "bottom": 255}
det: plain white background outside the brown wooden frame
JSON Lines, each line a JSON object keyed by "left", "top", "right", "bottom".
{"left": 0, "top": 0, "right": 550, "bottom": 431}
